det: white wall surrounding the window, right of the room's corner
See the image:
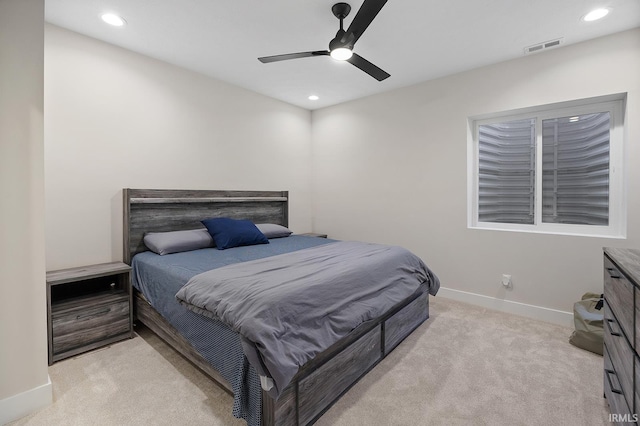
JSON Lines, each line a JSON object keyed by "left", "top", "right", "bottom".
{"left": 312, "top": 29, "right": 640, "bottom": 319}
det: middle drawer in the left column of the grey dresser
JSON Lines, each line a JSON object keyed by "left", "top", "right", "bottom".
{"left": 604, "top": 301, "right": 635, "bottom": 407}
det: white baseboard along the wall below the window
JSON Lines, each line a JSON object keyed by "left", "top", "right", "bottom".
{"left": 437, "top": 287, "right": 573, "bottom": 327}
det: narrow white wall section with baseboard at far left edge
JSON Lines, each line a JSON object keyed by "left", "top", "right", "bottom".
{"left": 0, "top": 0, "right": 51, "bottom": 424}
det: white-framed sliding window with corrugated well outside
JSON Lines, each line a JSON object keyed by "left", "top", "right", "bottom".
{"left": 469, "top": 95, "right": 626, "bottom": 237}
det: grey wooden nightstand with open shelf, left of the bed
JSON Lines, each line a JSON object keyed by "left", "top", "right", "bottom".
{"left": 47, "top": 262, "right": 133, "bottom": 365}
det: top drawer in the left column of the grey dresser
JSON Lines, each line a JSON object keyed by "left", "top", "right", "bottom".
{"left": 604, "top": 256, "right": 635, "bottom": 342}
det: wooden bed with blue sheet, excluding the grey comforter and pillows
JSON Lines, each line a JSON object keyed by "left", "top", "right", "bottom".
{"left": 123, "top": 189, "right": 438, "bottom": 426}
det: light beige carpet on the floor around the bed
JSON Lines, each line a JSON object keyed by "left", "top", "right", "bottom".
{"left": 11, "top": 297, "right": 608, "bottom": 426}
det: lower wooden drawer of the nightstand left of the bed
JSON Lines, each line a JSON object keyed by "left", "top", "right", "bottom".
{"left": 51, "top": 292, "right": 131, "bottom": 354}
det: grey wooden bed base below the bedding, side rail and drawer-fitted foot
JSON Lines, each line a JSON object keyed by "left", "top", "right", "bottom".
{"left": 134, "top": 291, "right": 429, "bottom": 426}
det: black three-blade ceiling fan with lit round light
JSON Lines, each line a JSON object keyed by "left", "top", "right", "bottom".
{"left": 258, "top": 0, "right": 391, "bottom": 81}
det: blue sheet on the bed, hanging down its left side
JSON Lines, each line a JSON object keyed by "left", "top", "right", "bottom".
{"left": 131, "top": 235, "right": 335, "bottom": 426}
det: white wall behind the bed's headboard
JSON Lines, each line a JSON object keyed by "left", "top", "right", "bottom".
{"left": 45, "top": 25, "right": 311, "bottom": 270}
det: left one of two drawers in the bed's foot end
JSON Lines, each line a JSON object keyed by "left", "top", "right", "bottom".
{"left": 298, "top": 327, "right": 382, "bottom": 425}
